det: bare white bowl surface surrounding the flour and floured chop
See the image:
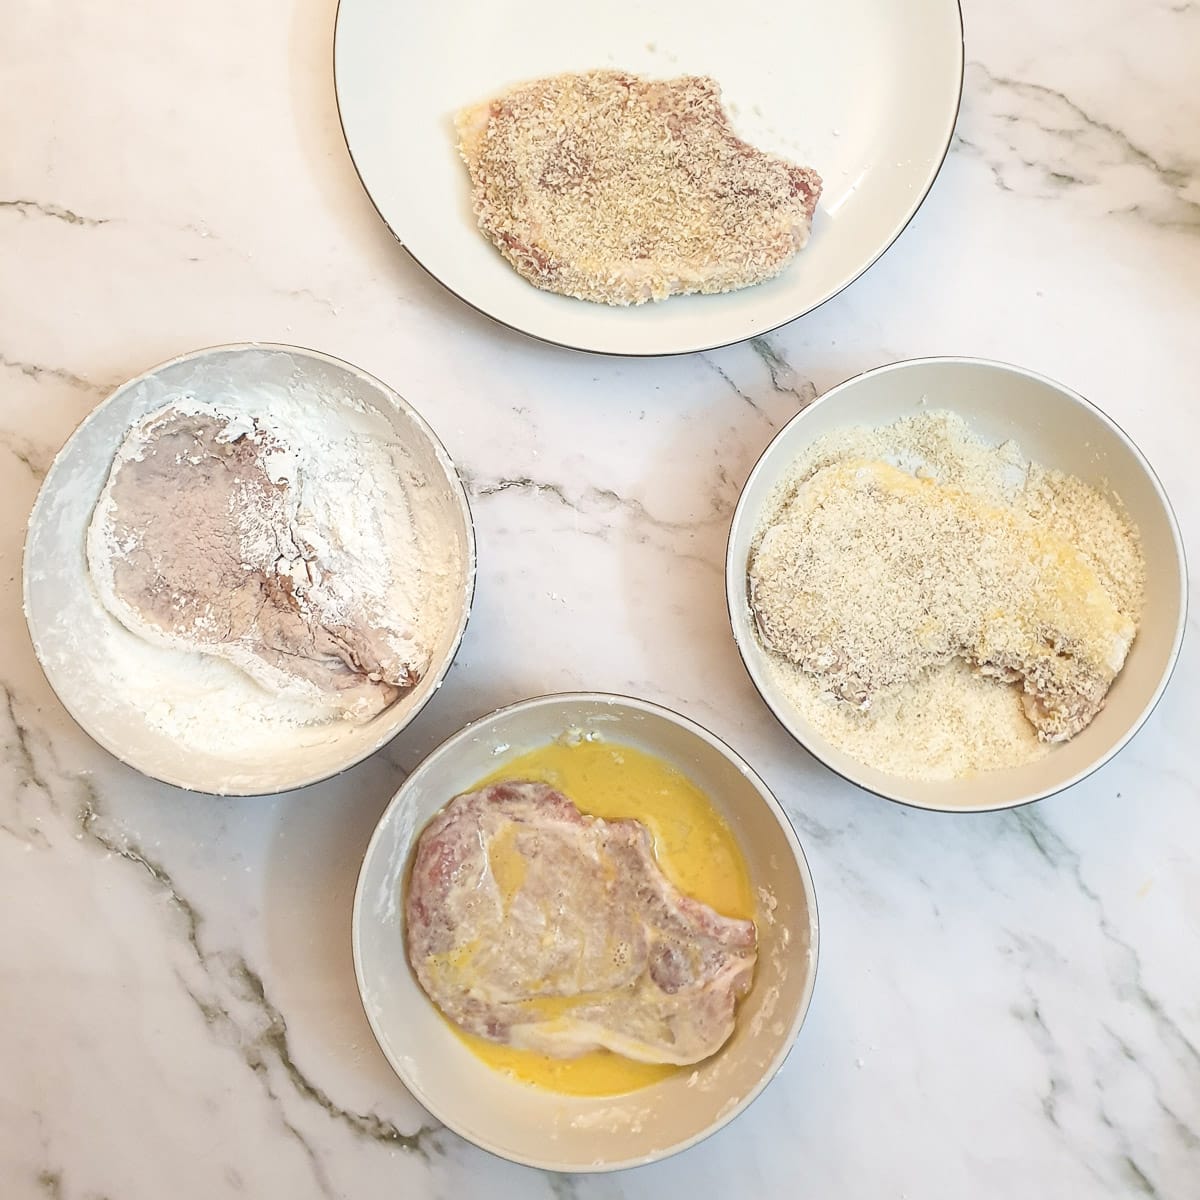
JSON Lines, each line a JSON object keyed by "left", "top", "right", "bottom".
{"left": 24, "top": 344, "right": 475, "bottom": 796}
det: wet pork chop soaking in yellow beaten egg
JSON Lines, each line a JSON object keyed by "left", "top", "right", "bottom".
{"left": 404, "top": 782, "right": 756, "bottom": 1063}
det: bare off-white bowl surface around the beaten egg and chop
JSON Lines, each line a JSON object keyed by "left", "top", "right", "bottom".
{"left": 354, "top": 692, "right": 817, "bottom": 1171}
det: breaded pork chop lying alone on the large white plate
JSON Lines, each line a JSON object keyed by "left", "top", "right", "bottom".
{"left": 456, "top": 71, "right": 821, "bottom": 305}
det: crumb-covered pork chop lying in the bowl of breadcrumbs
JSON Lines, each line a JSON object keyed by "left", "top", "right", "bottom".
{"left": 749, "top": 460, "right": 1136, "bottom": 742}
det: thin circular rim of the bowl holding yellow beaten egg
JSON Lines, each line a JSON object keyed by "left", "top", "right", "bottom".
{"left": 350, "top": 691, "right": 821, "bottom": 1174}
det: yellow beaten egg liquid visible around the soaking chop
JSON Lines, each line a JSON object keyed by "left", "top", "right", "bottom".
{"left": 451, "top": 738, "right": 755, "bottom": 1096}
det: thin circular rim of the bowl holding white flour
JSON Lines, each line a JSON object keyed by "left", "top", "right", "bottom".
{"left": 22, "top": 342, "right": 478, "bottom": 797}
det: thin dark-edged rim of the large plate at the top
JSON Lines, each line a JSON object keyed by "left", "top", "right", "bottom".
{"left": 330, "top": 0, "right": 966, "bottom": 359}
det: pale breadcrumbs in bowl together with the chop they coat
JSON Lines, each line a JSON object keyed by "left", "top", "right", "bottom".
{"left": 749, "top": 413, "right": 1145, "bottom": 778}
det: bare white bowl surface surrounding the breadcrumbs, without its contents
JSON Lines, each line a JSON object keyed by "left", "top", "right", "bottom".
{"left": 725, "top": 358, "right": 1187, "bottom": 811}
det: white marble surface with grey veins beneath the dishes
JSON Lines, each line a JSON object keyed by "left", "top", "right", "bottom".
{"left": 0, "top": 0, "right": 1200, "bottom": 1200}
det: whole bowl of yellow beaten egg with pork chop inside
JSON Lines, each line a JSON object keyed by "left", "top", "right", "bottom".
{"left": 354, "top": 694, "right": 817, "bottom": 1171}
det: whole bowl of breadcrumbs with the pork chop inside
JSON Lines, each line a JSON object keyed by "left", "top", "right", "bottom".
{"left": 726, "top": 359, "right": 1187, "bottom": 811}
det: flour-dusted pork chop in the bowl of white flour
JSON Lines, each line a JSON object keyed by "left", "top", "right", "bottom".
{"left": 88, "top": 406, "right": 424, "bottom": 716}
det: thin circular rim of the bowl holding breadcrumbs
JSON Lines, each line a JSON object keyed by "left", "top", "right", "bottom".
{"left": 725, "top": 355, "right": 1188, "bottom": 815}
